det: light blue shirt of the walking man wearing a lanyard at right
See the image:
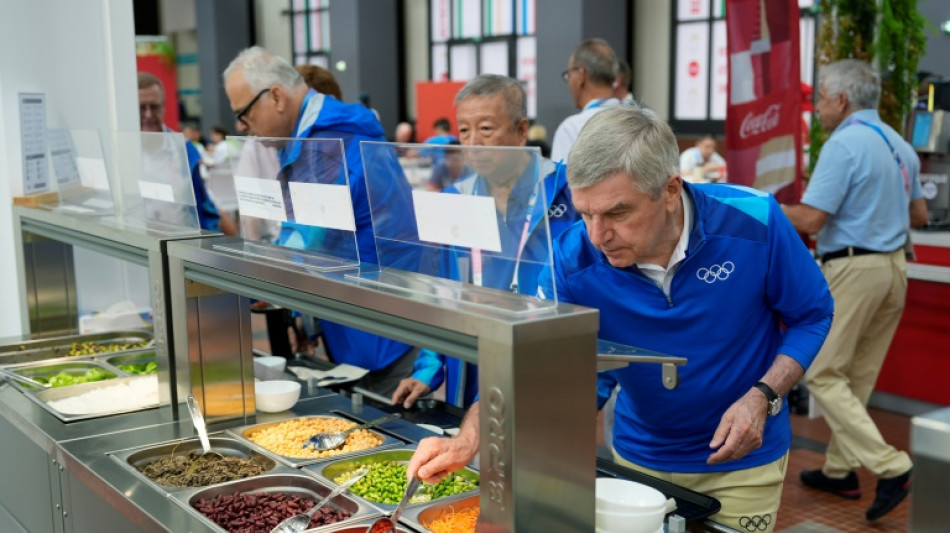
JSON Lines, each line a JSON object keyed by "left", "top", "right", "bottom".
{"left": 802, "top": 109, "right": 923, "bottom": 254}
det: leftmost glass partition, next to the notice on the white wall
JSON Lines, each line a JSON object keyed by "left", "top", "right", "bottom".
{"left": 44, "top": 129, "right": 115, "bottom": 215}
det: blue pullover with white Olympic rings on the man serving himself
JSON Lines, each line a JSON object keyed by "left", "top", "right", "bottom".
{"left": 540, "top": 184, "right": 833, "bottom": 473}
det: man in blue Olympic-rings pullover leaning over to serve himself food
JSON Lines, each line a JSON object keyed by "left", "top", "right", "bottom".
{"left": 408, "top": 106, "right": 833, "bottom": 532}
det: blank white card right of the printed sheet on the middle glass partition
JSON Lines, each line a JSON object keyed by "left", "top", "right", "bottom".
{"left": 289, "top": 182, "right": 356, "bottom": 231}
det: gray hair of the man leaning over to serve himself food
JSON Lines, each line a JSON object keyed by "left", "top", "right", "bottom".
{"left": 567, "top": 106, "right": 679, "bottom": 200}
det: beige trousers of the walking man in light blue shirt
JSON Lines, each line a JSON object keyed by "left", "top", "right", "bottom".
{"left": 805, "top": 249, "right": 911, "bottom": 478}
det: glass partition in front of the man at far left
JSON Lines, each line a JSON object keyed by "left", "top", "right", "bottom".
{"left": 112, "top": 131, "right": 200, "bottom": 235}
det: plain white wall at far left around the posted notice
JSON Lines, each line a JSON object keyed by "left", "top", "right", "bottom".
{"left": 0, "top": 0, "right": 139, "bottom": 337}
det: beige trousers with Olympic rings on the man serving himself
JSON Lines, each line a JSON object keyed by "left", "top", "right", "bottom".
{"left": 613, "top": 450, "right": 788, "bottom": 533}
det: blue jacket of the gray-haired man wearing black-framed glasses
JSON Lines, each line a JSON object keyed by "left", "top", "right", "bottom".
{"left": 280, "top": 90, "right": 414, "bottom": 370}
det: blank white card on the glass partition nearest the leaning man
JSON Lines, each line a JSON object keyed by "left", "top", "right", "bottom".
{"left": 412, "top": 190, "right": 501, "bottom": 252}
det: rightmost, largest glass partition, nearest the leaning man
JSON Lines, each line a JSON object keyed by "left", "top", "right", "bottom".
{"left": 362, "top": 141, "right": 557, "bottom": 314}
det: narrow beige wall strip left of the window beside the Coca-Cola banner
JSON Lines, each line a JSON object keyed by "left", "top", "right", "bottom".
{"left": 632, "top": 0, "right": 673, "bottom": 120}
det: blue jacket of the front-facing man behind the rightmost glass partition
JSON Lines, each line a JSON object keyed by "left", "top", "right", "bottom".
{"left": 412, "top": 159, "right": 580, "bottom": 407}
